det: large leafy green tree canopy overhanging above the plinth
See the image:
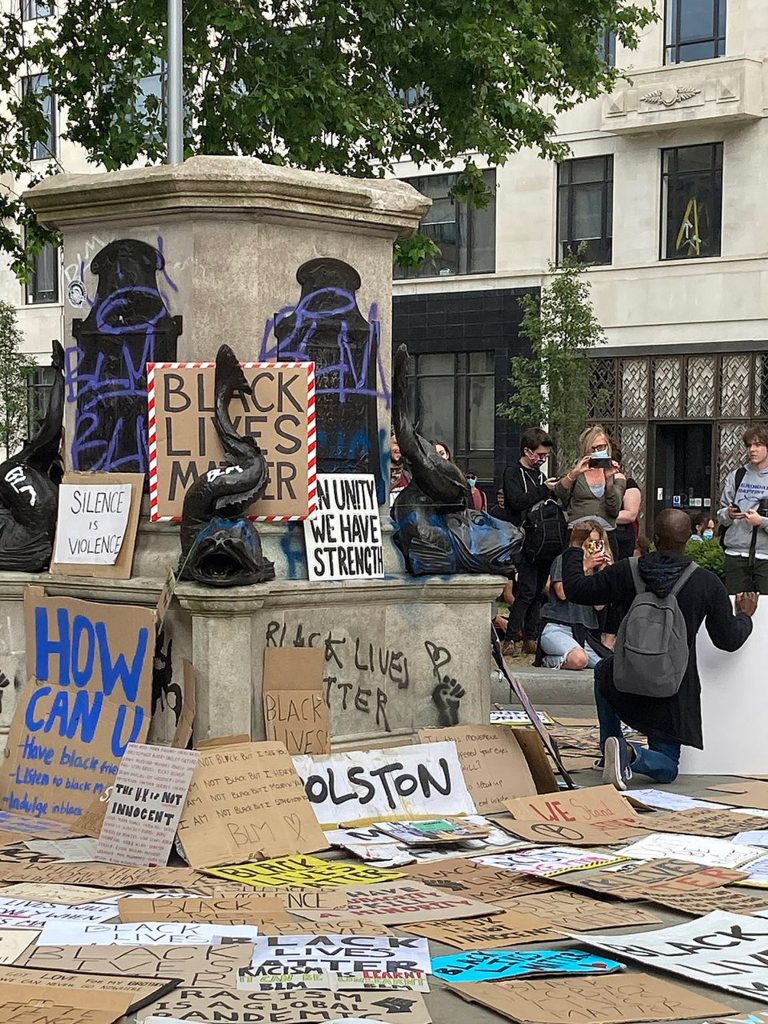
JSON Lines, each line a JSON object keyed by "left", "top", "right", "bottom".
{"left": 0, "top": 0, "right": 655, "bottom": 269}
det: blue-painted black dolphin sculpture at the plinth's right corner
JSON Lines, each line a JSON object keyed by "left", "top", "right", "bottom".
{"left": 392, "top": 345, "right": 523, "bottom": 577}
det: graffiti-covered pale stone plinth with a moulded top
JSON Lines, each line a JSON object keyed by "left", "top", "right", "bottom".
{"left": 16, "top": 157, "right": 502, "bottom": 742}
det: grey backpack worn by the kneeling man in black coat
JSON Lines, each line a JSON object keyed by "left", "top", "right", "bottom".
{"left": 613, "top": 558, "right": 698, "bottom": 697}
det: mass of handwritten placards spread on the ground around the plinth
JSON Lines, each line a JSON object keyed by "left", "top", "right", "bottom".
{"left": 0, "top": 588, "right": 768, "bottom": 1024}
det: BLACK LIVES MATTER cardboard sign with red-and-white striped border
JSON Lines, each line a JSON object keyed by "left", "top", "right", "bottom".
{"left": 146, "top": 362, "right": 316, "bottom": 522}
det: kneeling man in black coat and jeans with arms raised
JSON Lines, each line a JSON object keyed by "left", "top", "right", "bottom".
{"left": 562, "top": 509, "right": 758, "bottom": 790}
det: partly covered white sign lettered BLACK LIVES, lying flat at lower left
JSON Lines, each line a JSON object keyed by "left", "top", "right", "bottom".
{"left": 38, "top": 921, "right": 258, "bottom": 946}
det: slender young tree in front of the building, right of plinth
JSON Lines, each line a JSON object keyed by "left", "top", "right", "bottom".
{"left": 497, "top": 255, "right": 605, "bottom": 469}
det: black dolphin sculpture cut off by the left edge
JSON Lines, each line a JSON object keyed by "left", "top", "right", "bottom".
{"left": 0, "top": 341, "right": 65, "bottom": 572}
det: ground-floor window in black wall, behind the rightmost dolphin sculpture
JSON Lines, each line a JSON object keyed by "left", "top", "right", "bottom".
{"left": 410, "top": 351, "right": 496, "bottom": 480}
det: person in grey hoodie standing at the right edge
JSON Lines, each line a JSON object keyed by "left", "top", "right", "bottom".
{"left": 718, "top": 423, "right": 768, "bottom": 594}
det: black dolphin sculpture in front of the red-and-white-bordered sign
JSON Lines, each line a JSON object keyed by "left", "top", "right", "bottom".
{"left": 179, "top": 345, "right": 274, "bottom": 587}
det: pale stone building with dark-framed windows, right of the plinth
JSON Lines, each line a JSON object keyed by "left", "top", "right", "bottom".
{"left": 394, "top": 0, "right": 768, "bottom": 518}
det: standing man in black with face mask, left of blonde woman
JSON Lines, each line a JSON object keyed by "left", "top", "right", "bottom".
{"left": 502, "top": 427, "right": 554, "bottom": 656}
